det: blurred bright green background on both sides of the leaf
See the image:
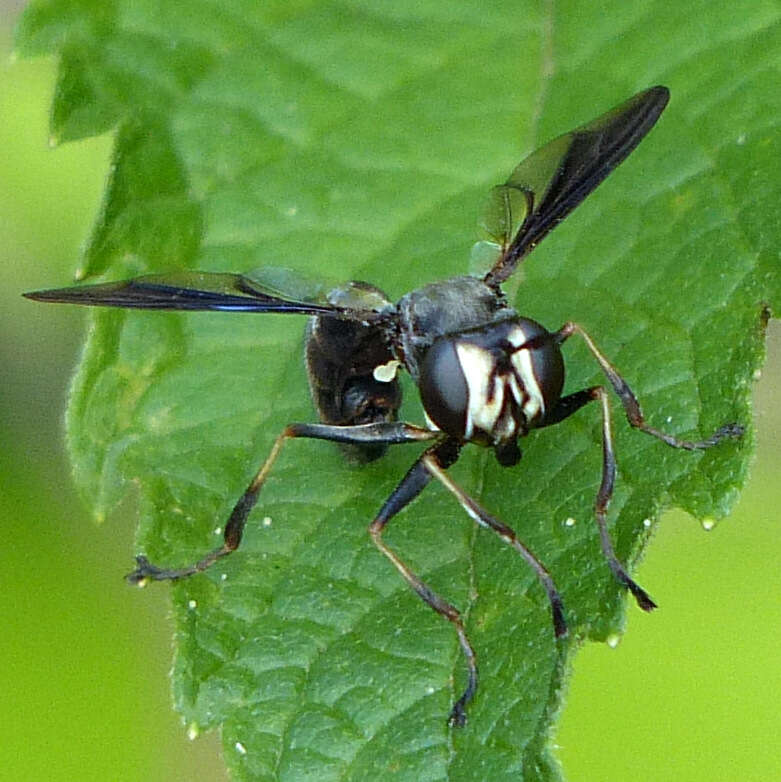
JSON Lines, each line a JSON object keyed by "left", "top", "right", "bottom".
{"left": 0, "top": 9, "right": 781, "bottom": 782}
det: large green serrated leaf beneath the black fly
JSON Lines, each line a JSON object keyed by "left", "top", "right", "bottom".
{"left": 18, "top": 0, "right": 781, "bottom": 782}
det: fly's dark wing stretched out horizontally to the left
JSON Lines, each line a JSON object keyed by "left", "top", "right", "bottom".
{"left": 24, "top": 271, "right": 388, "bottom": 321}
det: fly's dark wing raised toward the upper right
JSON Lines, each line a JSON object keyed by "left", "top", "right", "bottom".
{"left": 483, "top": 87, "right": 670, "bottom": 286}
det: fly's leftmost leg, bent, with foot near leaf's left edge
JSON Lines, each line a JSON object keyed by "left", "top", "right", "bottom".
{"left": 127, "top": 422, "right": 437, "bottom": 585}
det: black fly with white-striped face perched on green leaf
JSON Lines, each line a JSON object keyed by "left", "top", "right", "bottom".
{"left": 25, "top": 86, "right": 743, "bottom": 726}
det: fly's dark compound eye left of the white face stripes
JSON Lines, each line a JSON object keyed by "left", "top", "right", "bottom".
{"left": 419, "top": 337, "right": 469, "bottom": 437}
